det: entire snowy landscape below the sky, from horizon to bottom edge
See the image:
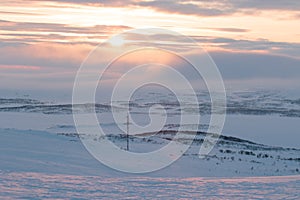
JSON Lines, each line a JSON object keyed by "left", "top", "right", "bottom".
{"left": 0, "top": 92, "right": 300, "bottom": 199}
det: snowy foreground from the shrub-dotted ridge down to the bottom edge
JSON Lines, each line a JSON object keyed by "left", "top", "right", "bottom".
{"left": 0, "top": 129, "right": 300, "bottom": 199}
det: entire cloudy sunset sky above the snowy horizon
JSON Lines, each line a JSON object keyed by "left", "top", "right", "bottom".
{"left": 0, "top": 0, "right": 300, "bottom": 95}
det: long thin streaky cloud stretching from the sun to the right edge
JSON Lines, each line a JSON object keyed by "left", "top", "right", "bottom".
{"left": 126, "top": 33, "right": 300, "bottom": 58}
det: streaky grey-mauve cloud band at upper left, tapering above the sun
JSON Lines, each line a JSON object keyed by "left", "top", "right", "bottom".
{"left": 0, "top": 20, "right": 131, "bottom": 46}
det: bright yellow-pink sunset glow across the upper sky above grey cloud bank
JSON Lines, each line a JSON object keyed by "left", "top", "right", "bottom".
{"left": 0, "top": 0, "right": 300, "bottom": 90}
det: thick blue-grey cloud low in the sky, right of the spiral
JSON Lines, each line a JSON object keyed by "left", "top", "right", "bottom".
{"left": 210, "top": 52, "right": 300, "bottom": 79}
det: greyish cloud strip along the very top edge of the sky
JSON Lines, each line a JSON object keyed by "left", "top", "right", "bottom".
{"left": 44, "top": 0, "right": 300, "bottom": 16}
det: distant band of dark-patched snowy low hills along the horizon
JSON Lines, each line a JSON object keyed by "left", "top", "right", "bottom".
{"left": 0, "top": 91, "right": 300, "bottom": 117}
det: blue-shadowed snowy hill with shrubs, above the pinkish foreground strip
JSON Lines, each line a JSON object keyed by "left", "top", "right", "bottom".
{"left": 0, "top": 129, "right": 300, "bottom": 177}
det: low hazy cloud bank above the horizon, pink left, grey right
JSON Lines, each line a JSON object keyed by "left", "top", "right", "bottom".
{"left": 0, "top": 41, "right": 300, "bottom": 89}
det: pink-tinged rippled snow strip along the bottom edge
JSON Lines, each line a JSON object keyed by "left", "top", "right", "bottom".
{"left": 0, "top": 172, "right": 300, "bottom": 199}
